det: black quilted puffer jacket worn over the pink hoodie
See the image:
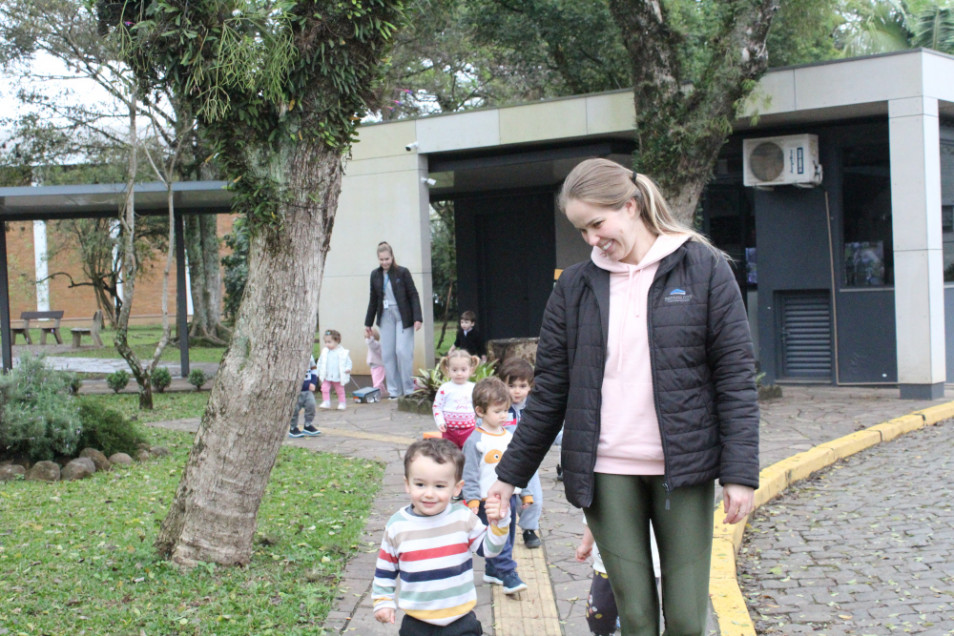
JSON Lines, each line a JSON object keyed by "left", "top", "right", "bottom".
{"left": 497, "top": 242, "right": 759, "bottom": 508}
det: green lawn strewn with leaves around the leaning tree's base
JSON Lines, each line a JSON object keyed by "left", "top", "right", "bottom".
{"left": 0, "top": 429, "right": 383, "bottom": 636}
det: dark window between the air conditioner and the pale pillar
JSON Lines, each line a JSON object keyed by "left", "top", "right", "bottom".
{"left": 842, "top": 143, "right": 894, "bottom": 287}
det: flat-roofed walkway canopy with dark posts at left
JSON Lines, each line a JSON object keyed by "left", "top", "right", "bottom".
{"left": 0, "top": 181, "right": 232, "bottom": 377}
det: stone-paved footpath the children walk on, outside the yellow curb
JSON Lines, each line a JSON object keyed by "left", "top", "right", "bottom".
{"left": 149, "top": 385, "right": 944, "bottom": 636}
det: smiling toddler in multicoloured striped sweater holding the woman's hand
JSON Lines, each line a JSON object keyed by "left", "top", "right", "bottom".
{"left": 372, "top": 439, "right": 510, "bottom": 636}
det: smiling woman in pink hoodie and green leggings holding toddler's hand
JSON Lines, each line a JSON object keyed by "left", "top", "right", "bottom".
{"left": 490, "top": 159, "right": 759, "bottom": 636}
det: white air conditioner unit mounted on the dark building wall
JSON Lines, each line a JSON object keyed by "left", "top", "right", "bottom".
{"left": 742, "top": 135, "right": 822, "bottom": 188}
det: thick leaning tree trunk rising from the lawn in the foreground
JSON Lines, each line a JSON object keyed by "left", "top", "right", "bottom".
{"left": 156, "top": 143, "right": 343, "bottom": 566}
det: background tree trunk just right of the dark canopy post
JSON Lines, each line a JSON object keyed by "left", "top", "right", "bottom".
{"left": 185, "top": 214, "right": 231, "bottom": 345}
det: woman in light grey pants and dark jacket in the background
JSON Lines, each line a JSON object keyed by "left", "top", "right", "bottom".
{"left": 364, "top": 241, "right": 423, "bottom": 399}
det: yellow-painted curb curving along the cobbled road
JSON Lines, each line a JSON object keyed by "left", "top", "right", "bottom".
{"left": 709, "top": 402, "right": 954, "bottom": 636}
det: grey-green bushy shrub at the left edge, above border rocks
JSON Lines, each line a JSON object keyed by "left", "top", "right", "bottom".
{"left": 0, "top": 355, "right": 80, "bottom": 461}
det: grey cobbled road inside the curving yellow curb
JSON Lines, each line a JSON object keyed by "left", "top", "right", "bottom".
{"left": 740, "top": 420, "right": 954, "bottom": 636}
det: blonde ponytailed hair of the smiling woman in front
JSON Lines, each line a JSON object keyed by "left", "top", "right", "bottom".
{"left": 559, "top": 159, "right": 722, "bottom": 254}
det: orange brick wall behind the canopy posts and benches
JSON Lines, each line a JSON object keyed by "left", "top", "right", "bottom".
{"left": 6, "top": 214, "right": 233, "bottom": 326}
